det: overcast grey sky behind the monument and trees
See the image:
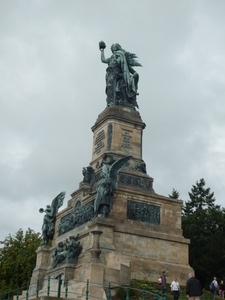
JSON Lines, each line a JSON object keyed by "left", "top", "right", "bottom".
{"left": 0, "top": 0, "right": 225, "bottom": 240}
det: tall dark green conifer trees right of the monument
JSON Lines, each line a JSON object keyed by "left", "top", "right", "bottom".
{"left": 182, "top": 178, "right": 225, "bottom": 287}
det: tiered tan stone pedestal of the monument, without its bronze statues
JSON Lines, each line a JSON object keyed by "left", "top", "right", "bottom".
{"left": 23, "top": 106, "right": 192, "bottom": 299}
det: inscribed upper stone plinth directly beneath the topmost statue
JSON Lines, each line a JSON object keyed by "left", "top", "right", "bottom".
{"left": 92, "top": 106, "right": 145, "bottom": 164}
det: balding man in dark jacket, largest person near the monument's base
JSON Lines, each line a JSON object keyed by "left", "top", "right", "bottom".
{"left": 186, "top": 272, "right": 202, "bottom": 300}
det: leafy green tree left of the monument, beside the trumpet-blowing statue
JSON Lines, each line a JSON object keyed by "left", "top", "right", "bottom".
{"left": 0, "top": 228, "right": 41, "bottom": 294}
